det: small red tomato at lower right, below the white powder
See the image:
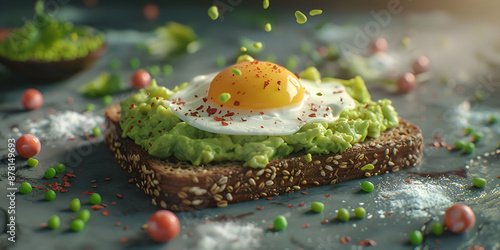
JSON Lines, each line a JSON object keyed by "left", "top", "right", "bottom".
{"left": 444, "top": 204, "right": 476, "bottom": 233}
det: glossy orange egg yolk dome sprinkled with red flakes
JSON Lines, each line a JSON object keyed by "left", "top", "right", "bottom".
{"left": 207, "top": 61, "right": 305, "bottom": 110}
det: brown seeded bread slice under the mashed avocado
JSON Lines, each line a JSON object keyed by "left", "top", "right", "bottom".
{"left": 105, "top": 104, "right": 423, "bottom": 211}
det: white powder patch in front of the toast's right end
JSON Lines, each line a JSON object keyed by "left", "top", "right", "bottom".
{"left": 377, "top": 180, "right": 452, "bottom": 218}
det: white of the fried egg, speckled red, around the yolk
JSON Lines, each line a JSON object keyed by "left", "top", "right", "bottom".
{"left": 166, "top": 73, "right": 356, "bottom": 135}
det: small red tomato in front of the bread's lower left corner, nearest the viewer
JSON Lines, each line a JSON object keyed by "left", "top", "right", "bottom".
{"left": 148, "top": 210, "right": 181, "bottom": 242}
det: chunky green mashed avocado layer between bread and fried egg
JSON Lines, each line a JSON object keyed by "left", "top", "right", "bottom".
{"left": 120, "top": 70, "right": 398, "bottom": 168}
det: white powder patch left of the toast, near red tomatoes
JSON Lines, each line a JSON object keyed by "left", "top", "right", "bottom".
{"left": 12, "top": 110, "right": 104, "bottom": 140}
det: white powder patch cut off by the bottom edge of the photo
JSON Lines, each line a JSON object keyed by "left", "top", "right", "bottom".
{"left": 194, "top": 222, "right": 263, "bottom": 250}
